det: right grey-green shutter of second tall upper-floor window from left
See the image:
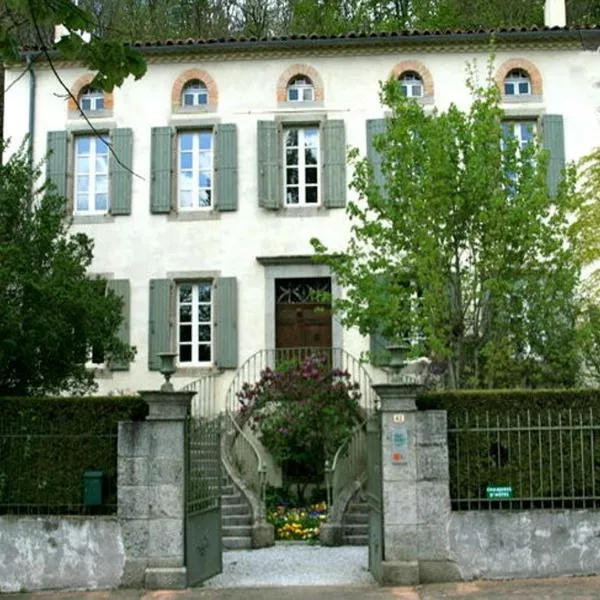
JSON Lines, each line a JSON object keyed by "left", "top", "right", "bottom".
{"left": 215, "top": 124, "right": 238, "bottom": 211}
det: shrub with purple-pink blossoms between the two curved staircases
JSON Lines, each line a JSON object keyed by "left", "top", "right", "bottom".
{"left": 238, "top": 355, "right": 360, "bottom": 483}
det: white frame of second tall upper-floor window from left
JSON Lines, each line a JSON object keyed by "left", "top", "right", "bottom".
{"left": 177, "top": 129, "right": 215, "bottom": 212}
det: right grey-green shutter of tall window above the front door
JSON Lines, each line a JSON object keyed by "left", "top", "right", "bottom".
{"left": 322, "top": 120, "right": 346, "bottom": 208}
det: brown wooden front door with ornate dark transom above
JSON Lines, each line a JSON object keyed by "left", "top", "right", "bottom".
{"left": 275, "top": 277, "right": 332, "bottom": 348}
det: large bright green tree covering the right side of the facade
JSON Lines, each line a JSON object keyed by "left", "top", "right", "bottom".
{"left": 312, "top": 66, "right": 581, "bottom": 388}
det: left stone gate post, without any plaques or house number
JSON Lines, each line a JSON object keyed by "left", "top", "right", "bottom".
{"left": 118, "top": 391, "right": 194, "bottom": 589}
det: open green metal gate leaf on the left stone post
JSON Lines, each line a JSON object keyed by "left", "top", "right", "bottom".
{"left": 185, "top": 417, "right": 223, "bottom": 586}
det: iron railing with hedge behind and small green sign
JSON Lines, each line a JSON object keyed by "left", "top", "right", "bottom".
{"left": 448, "top": 408, "right": 600, "bottom": 510}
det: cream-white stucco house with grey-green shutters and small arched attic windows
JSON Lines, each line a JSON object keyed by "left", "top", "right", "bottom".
{"left": 4, "top": 2, "right": 600, "bottom": 404}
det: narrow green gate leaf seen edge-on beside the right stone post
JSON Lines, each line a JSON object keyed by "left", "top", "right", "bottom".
{"left": 367, "top": 413, "right": 383, "bottom": 583}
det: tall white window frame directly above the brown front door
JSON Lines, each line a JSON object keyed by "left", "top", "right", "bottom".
{"left": 282, "top": 125, "right": 322, "bottom": 208}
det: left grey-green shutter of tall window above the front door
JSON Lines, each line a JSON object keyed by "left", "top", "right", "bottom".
{"left": 257, "top": 121, "right": 283, "bottom": 210}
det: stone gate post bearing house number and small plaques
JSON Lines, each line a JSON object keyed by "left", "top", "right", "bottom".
{"left": 373, "top": 378, "right": 461, "bottom": 585}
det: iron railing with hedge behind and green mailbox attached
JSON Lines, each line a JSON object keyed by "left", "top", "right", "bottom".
{"left": 0, "top": 419, "right": 118, "bottom": 515}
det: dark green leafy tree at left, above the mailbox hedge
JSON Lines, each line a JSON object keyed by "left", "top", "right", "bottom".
{"left": 0, "top": 142, "right": 133, "bottom": 396}
